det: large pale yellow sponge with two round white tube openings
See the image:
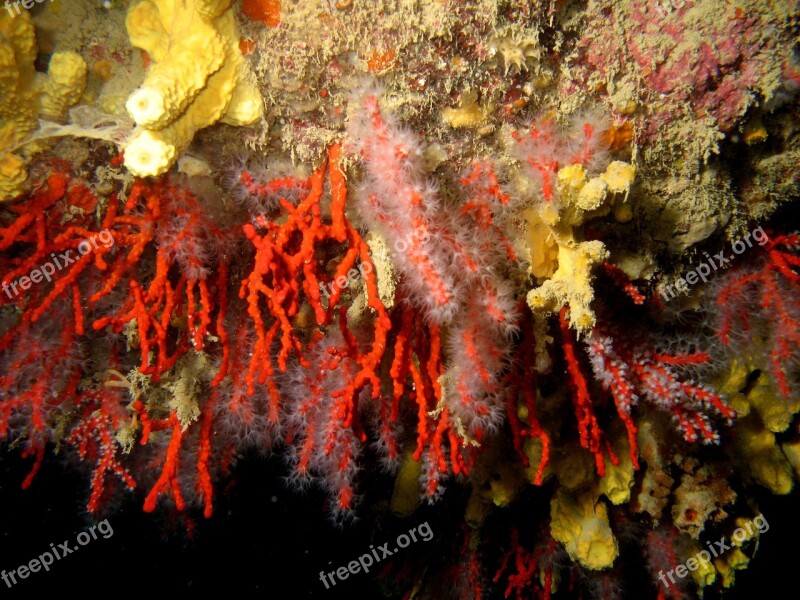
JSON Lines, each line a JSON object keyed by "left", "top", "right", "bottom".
{"left": 125, "top": 0, "right": 263, "bottom": 176}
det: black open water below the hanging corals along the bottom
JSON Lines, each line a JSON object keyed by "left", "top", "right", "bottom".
{"left": 0, "top": 452, "right": 800, "bottom": 599}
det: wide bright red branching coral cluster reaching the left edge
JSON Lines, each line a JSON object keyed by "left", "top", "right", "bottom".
{"left": 0, "top": 172, "right": 234, "bottom": 381}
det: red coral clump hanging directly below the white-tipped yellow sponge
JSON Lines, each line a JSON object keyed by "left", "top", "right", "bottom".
{"left": 89, "top": 180, "right": 233, "bottom": 381}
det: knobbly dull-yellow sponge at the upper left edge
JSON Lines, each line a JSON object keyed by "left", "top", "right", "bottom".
{"left": 0, "top": 11, "right": 86, "bottom": 201}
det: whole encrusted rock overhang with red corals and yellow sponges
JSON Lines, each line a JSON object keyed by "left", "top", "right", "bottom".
{"left": 0, "top": 0, "right": 800, "bottom": 599}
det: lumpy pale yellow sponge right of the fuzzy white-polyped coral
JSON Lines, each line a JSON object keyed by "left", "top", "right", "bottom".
{"left": 525, "top": 161, "right": 636, "bottom": 332}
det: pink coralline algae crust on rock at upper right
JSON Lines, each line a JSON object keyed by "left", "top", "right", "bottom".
{"left": 567, "top": 0, "right": 791, "bottom": 141}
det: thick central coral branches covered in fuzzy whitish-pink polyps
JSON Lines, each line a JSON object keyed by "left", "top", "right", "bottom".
{"left": 348, "top": 89, "right": 518, "bottom": 450}
